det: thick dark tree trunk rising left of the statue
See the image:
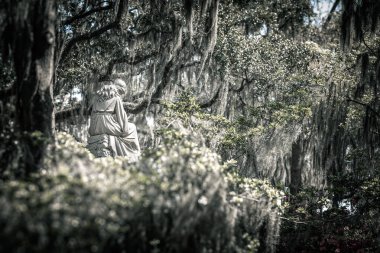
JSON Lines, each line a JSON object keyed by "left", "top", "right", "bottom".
{"left": 8, "top": 0, "right": 56, "bottom": 174}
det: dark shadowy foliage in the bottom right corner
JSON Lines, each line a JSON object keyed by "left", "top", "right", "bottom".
{"left": 280, "top": 173, "right": 380, "bottom": 252}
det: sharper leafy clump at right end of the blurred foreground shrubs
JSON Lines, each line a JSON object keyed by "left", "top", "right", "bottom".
{"left": 224, "top": 160, "right": 283, "bottom": 252}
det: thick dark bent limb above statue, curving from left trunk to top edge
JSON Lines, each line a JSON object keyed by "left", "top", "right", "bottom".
{"left": 59, "top": 0, "right": 128, "bottom": 62}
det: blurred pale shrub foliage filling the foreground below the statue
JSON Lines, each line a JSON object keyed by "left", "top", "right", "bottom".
{"left": 0, "top": 133, "right": 280, "bottom": 252}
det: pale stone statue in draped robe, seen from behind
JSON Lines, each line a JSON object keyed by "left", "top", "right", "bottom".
{"left": 87, "top": 79, "right": 140, "bottom": 161}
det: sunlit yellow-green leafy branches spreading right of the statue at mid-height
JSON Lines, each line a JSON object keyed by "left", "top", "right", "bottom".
{"left": 156, "top": 92, "right": 311, "bottom": 159}
